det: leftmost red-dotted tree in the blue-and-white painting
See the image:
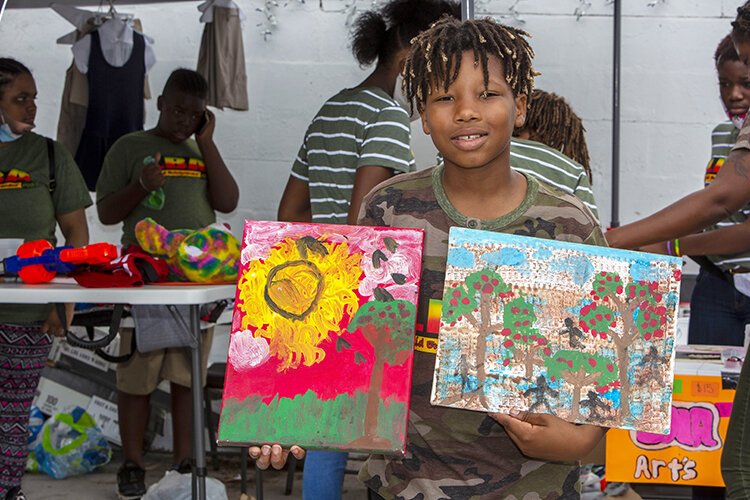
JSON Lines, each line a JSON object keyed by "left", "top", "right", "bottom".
{"left": 443, "top": 268, "right": 514, "bottom": 409}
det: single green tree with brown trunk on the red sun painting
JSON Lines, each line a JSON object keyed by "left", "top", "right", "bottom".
{"left": 347, "top": 289, "right": 416, "bottom": 446}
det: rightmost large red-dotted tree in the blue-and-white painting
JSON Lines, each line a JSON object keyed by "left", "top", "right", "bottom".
{"left": 578, "top": 271, "right": 667, "bottom": 419}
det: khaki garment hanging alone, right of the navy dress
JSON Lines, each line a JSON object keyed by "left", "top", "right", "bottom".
{"left": 197, "top": 0, "right": 249, "bottom": 111}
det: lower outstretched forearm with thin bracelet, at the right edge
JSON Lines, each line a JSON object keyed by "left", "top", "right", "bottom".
{"left": 640, "top": 219, "right": 750, "bottom": 255}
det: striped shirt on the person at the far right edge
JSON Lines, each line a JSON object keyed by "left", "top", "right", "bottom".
{"left": 703, "top": 121, "right": 750, "bottom": 270}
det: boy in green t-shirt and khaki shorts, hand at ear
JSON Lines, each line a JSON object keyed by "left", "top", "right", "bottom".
{"left": 96, "top": 69, "right": 239, "bottom": 498}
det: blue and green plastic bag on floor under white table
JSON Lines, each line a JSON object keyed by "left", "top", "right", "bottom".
{"left": 34, "top": 406, "right": 112, "bottom": 479}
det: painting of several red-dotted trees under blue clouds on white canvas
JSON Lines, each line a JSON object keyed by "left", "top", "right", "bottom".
{"left": 431, "top": 227, "right": 681, "bottom": 432}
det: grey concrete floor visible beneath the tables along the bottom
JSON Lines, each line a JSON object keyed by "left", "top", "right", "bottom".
{"left": 23, "top": 453, "right": 367, "bottom": 500}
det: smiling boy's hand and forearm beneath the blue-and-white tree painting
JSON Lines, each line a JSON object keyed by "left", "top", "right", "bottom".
{"left": 490, "top": 411, "right": 608, "bottom": 462}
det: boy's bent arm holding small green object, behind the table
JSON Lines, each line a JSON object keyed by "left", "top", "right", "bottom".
{"left": 96, "top": 153, "right": 166, "bottom": 224}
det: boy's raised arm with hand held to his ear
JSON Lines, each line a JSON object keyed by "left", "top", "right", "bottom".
{"left": 195, "top": 109, "right": 240, "bottom": 213}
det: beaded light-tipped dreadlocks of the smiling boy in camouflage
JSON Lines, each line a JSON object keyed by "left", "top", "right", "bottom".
{"left": 404, "top": 17, "right": 537, "bottom": 111}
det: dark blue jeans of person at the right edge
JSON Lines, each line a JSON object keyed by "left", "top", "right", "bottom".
{"left": 688, "top": 269, "right": 750, "bottom": 345}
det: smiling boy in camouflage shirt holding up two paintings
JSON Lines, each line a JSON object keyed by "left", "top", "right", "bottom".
{"left": 250, "top": 18, "right": 606, "bottom": 500}
